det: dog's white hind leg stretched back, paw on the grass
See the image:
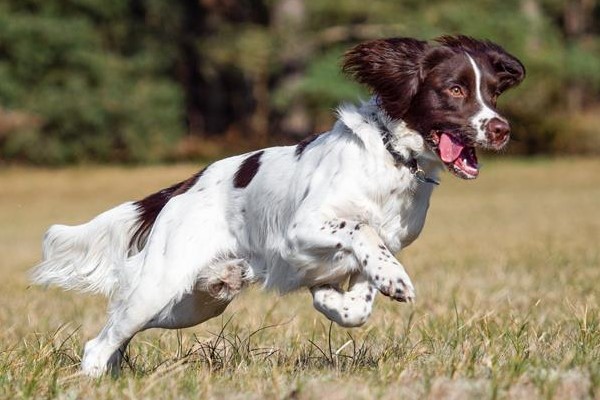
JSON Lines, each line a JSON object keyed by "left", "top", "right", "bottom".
{"left": 81, "top": 196, "right": 241, "bottom": 376}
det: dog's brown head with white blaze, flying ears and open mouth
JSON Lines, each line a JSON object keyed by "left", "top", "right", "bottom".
{"left": 343, "top": 36, "right": 525, "bottom": 179}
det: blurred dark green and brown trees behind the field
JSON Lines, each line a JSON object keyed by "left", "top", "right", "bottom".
{"left": 0, "top": 0, "right": 600, "bottom": 165}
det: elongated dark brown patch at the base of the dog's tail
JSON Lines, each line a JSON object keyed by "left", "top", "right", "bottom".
{"left": 129, "top": 167, "right": 208, "bottom": 250}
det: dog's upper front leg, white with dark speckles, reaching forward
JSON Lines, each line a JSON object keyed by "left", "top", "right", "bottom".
{"left": 285, "top": 219, "right": 415, "bottom": 304}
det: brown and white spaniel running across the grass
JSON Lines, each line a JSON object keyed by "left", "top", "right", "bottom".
{"left": 32, "top": 36, "right": 525, "bottom": 376}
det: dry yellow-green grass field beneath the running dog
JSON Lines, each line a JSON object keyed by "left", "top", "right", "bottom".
{"left": 0, "top": 159, "right": 600, "bottom": 400}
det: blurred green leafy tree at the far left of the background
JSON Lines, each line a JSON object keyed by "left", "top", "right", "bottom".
{"left": 0, "top": 0, "right": 183, "bottom": 164}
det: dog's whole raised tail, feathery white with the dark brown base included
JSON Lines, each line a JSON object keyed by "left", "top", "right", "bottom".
{"left": 31, "top": 170, "right": 204, "bottom": 296}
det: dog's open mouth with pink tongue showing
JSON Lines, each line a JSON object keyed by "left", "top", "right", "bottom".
{"left": 430, "top": 132, "right": 479, "bottom": 179}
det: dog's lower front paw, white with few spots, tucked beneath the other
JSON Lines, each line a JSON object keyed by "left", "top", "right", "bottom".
{"left": 310, "top": 273, "right": 376, "bottom": 328}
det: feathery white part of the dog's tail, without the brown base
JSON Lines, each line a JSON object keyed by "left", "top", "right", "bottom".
{"left": 31, "top": 202, "right": 140, "bottom": 296}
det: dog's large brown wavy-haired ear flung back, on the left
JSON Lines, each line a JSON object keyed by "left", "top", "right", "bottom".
{"left": 342, "top": 38, "right": 430, "bottom": 119}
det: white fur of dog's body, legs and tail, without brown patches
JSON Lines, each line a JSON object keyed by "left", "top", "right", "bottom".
{"left": 34, "top": 97, "right": 441, "bottom": 376}
